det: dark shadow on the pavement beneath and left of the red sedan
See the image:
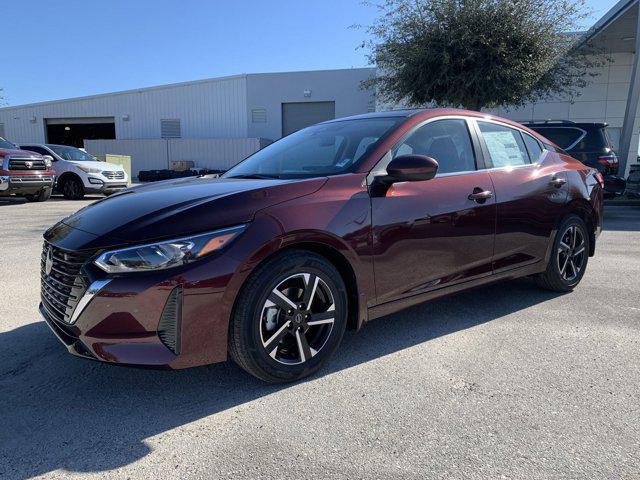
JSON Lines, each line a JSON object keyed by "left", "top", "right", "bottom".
{"left": 0, "top": 279, "right": 558, "bottom": 479}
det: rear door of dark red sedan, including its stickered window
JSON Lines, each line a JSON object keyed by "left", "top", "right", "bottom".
{"left": 476, "top": 120, "right": 567, "bottom": 273}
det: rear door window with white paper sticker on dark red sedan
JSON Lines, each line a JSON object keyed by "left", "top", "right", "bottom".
{"left": 478, "top": 122, "right": 529, "bottom": 168}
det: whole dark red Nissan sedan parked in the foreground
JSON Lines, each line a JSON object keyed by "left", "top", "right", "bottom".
{"left": 40, "top": 110, "right": 602, "bottom": 382}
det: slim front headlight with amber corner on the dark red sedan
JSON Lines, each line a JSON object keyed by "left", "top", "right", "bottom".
{"left": 93, "top": 225, "right": 247, "bottom": 273}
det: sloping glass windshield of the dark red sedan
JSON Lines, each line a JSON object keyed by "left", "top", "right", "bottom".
{"left": 224, "top": 117, "right": 404, "bottom": 178}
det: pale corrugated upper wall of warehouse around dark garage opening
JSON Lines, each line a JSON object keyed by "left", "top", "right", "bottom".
{"left": 0, "top": 76, "right": 248, "bottom": 143}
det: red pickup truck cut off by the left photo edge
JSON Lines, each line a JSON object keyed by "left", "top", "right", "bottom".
{"left": 0, "top": 137, "right": 56, "bottom": 202}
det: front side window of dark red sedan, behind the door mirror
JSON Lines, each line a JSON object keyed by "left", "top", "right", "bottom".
{"left": 392, "top": 119, "right": 476, "bottom": 173}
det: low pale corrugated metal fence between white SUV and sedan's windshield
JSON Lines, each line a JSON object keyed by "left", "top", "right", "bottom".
{"left": 85, "top": 138, "right": 266, "bottom": 176}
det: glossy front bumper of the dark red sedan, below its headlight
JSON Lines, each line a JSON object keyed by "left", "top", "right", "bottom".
{"left": 40, "top": 242, "right": 239, "bottom": 369}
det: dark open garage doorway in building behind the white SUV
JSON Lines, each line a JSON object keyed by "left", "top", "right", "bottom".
{"left": 45, "top": 117, "right": 116, "bottom": 148}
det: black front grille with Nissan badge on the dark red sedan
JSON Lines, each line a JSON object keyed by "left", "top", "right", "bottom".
{"left": 40, "top": 242, "right": 95, "bottom": 323}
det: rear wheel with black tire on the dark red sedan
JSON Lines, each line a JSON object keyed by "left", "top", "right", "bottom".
{"left": 535, "top": 215, "right": 590, "bottom": 292}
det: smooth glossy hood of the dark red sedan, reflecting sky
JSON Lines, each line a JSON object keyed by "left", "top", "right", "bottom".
{"left": 45, "top": 177, "right": 326, "bottom": 250}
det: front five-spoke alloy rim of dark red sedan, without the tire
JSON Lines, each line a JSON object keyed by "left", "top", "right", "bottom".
{"left": 260, "top": 272, "right": 336, "bottom": 365}
